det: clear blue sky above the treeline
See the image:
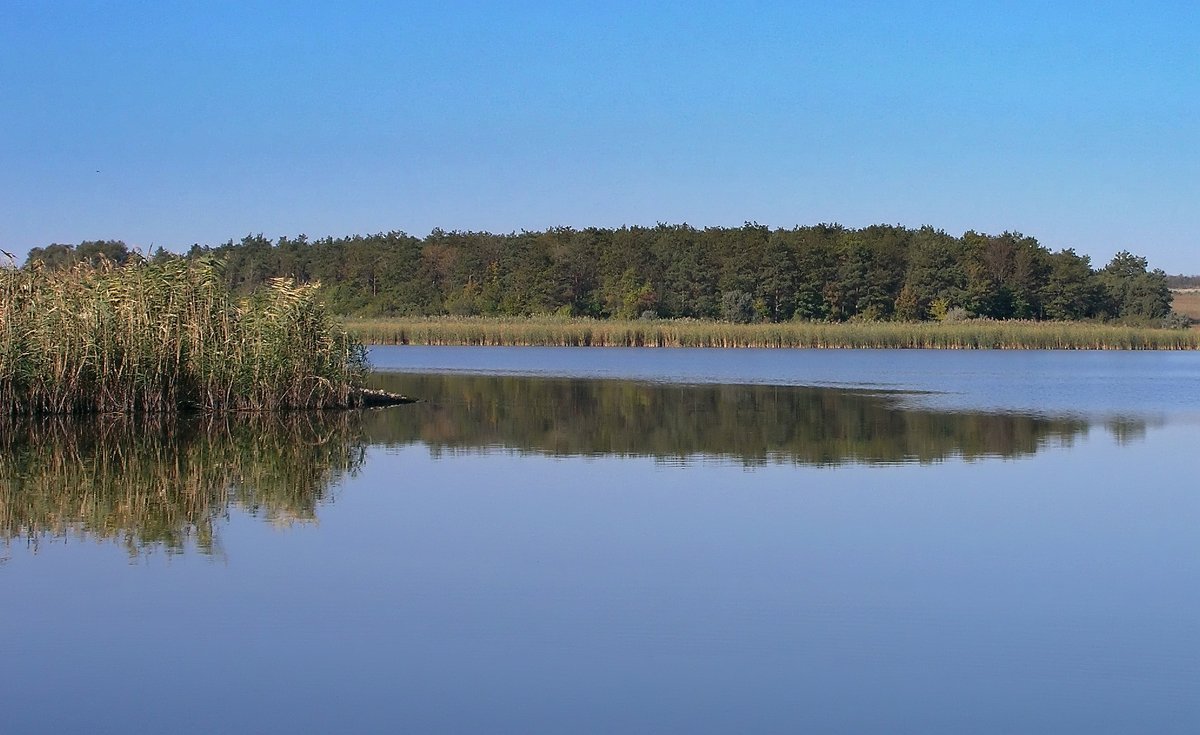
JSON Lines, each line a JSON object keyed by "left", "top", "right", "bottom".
{"left": 0, "top": 0, "right": 1200, "bottom": 274}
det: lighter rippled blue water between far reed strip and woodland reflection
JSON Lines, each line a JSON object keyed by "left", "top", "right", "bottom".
{"left": 372, "top": 347, "right": 1200, "bottom": 418}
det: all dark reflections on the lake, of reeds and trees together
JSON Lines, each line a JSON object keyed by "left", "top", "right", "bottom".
{"left": 0, "top": 374, "right": 1146, "bottom": 555}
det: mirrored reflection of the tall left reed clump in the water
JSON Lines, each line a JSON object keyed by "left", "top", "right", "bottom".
{"left": 0, "top": 412, "right": 365, "bottom": 554}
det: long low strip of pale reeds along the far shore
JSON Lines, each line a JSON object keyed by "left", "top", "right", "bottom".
{"left": 346, "top": 317, "right": 1200, "bottom": 349}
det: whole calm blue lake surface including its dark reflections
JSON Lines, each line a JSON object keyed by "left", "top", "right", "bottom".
{"left": 0, "top": 347, "right": 1200, "bottom": 733}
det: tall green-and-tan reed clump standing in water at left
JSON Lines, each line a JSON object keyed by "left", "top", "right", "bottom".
{"left": 0, "top": 258, "right": 366, "bottom": 416}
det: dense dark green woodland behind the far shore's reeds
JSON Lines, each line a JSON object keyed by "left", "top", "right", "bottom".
{"left": 23, "top": 223, "right": 1171, "bottom": 322}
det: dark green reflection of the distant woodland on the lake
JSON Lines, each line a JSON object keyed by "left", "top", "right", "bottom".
{"left": 368, "top": 375, "right": 1113, "bottom": 466}
